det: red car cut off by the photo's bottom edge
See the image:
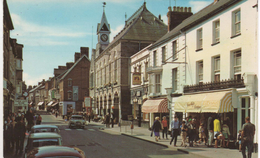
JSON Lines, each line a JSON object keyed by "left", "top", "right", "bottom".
{"left": 27, "top": 146, "right": 86, "bottom": 158}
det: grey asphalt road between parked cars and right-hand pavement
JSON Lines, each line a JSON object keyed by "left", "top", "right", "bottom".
{"left": 4, "top": 111, "right": 203, "bottom": 158}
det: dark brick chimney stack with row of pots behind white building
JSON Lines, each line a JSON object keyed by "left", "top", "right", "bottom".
{"left": 167, "top": 6, "right": 193, "bottom": 32}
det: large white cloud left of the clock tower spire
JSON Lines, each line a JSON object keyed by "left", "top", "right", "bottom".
{"left": 11, "top": 14, "right": 88, "bottom": 46}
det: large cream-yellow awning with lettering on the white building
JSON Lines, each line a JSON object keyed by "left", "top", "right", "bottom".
{"left": 174, "top": 91, "right": 234, "bottom": 113}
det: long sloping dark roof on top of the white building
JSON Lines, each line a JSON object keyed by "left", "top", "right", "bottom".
{"left": 148, "top": 0, "right": 241, "bottom": 50}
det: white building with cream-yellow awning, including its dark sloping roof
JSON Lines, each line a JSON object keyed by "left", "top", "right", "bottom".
{"left": 148, "top": 0, "right": 258, "bottom": 141}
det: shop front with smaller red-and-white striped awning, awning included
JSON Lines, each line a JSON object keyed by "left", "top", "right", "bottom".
{"left": 142, "top": 98, "right": 169, "bottom": 128}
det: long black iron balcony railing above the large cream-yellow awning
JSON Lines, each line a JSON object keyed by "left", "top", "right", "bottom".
{"left": 183, "top": 78, "right": 245, "bottom": 93}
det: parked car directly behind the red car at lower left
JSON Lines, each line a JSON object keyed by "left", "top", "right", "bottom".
{"left": 25, "top": 132, "right": 62, "bottom": 157}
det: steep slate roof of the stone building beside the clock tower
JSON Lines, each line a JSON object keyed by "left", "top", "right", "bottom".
{"left": 98, "top": 2, "right": 167, "bottom": 55}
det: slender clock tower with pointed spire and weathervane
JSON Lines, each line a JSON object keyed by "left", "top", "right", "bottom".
{"left": 96, "top": 2, "right": 110, "bottom": 56}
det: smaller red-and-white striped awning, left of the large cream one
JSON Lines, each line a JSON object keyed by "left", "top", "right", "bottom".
{"left": 142, "top": 99, "right": 169, "bottom": 113}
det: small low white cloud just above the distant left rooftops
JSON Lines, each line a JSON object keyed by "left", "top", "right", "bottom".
{"left": 23, "top": 72, "right": 53, "bottom": 86}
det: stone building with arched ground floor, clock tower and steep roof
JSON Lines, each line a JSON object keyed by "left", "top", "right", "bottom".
{"left": 90, "top": 2, "right": 167, "bottom": 120}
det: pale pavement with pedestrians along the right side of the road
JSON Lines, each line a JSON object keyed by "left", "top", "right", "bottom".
{"left": 89, "top": 121, "right": 258, "bottom": 158}
